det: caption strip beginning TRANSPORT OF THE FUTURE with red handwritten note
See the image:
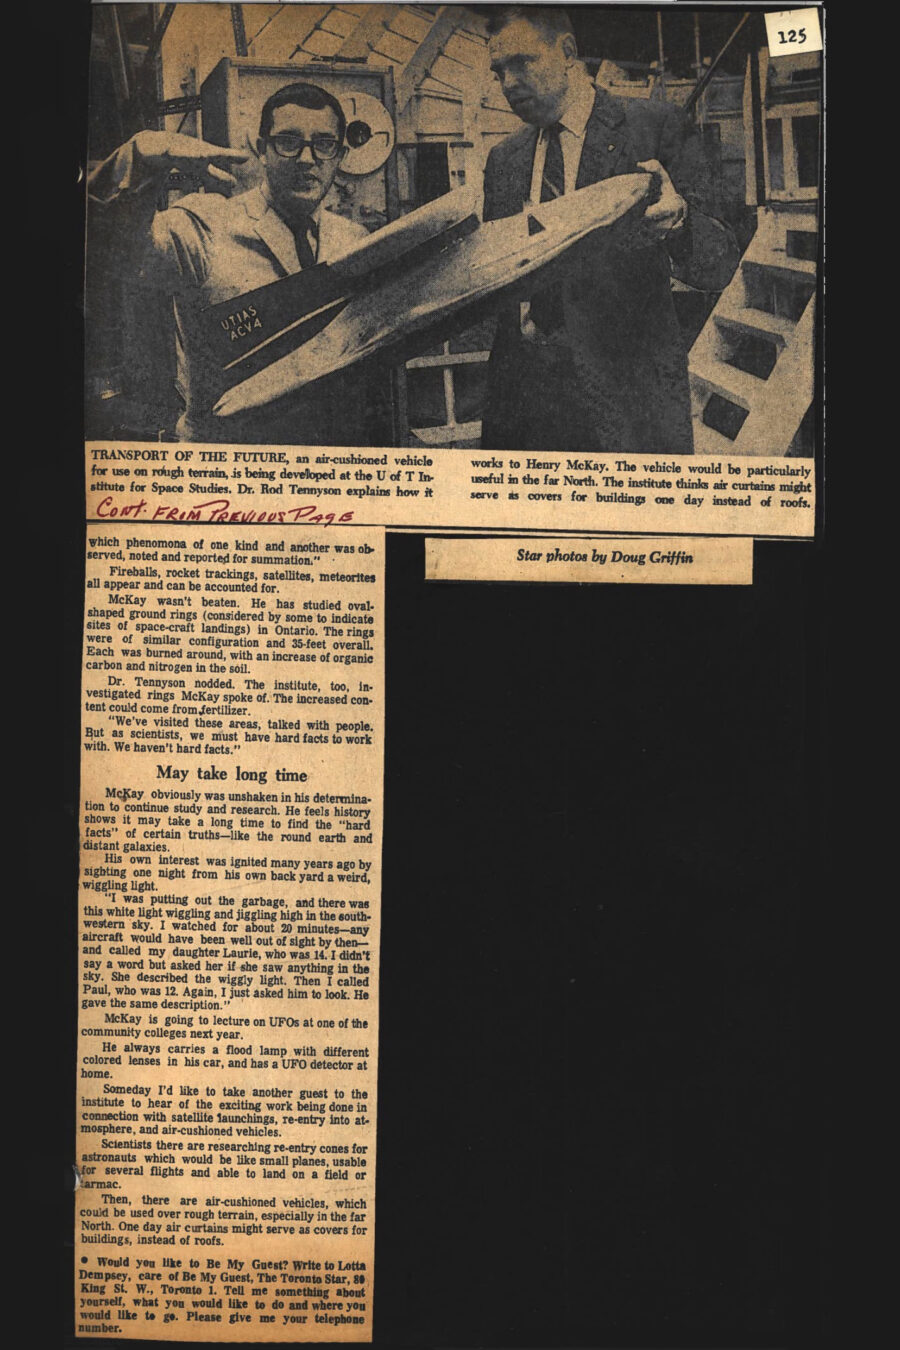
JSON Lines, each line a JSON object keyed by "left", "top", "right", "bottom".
{"left": 85, "top": 441, "right": 815, "bottom": 539}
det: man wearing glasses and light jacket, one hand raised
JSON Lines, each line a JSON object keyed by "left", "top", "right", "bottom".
{"left": 89, "top": 84, "right": 367, "bottom": 446}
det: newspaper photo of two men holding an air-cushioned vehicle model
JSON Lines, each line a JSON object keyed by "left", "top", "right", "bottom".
{"left": 86, "top": 4, "right": 822, "bottom": 456}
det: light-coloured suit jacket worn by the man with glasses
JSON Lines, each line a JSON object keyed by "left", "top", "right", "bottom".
{"left": 90, "top": 143, "right": 367, "bottom": 446}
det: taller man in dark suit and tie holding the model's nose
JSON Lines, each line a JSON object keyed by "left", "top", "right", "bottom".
{"left": 482, "top": 5, "right": 738, "bottom": 455}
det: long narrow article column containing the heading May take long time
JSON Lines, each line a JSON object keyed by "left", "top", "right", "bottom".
{"left": 76, "top": 522, "right": 385, "bottom": 1341}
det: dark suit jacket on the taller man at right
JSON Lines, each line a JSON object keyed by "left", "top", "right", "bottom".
{"left": 482, "top": 89, "right": 739, "bottom": 455}
